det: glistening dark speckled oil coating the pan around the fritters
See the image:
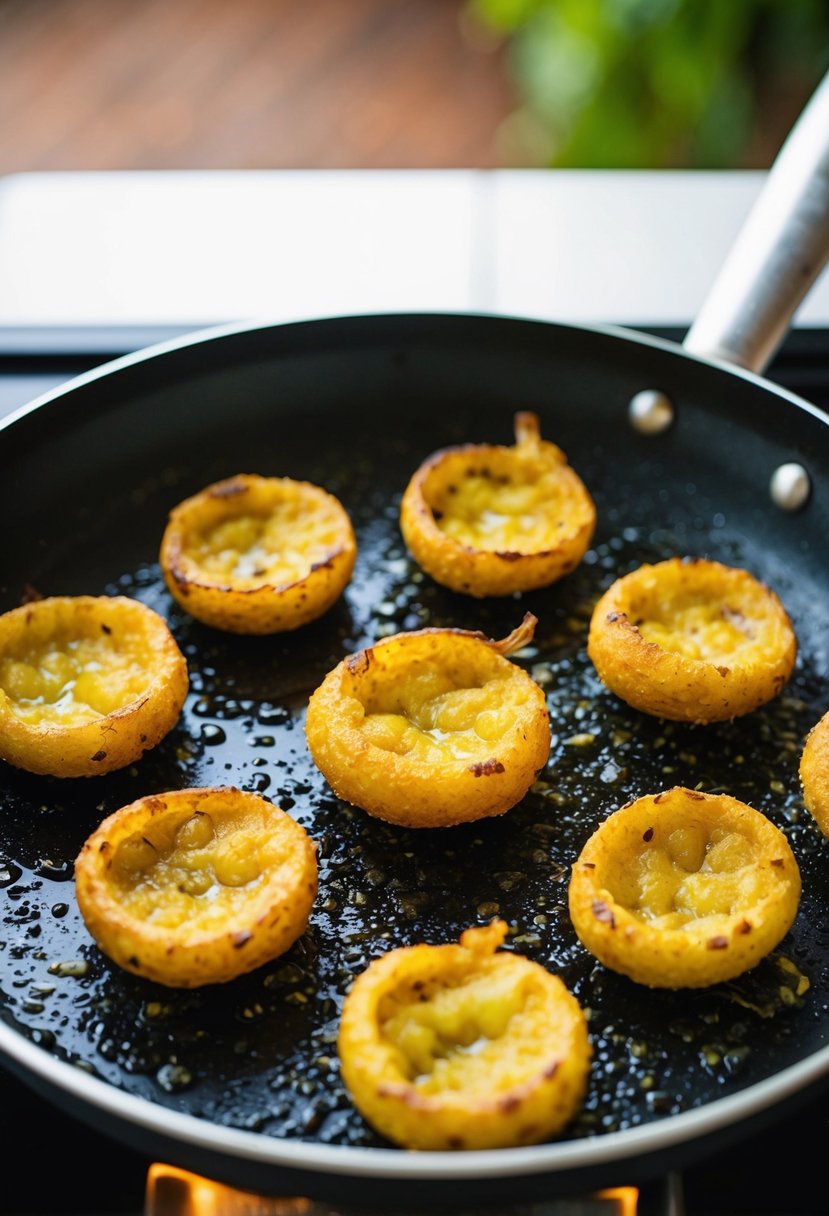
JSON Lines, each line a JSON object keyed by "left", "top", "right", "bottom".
{"left": 0, "top": 406, "right": 829, "bottom": 1145}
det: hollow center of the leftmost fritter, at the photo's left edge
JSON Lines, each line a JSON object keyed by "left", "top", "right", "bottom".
{"left": 0, "top": 631, "right": 154, "bottom": 726}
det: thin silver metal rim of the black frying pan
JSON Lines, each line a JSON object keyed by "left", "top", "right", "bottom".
{"left": 0, "top": 310, "right": 829, "bottom": 1181}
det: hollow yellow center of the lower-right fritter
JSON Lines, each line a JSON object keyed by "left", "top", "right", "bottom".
{"left": 611, "top": 824, "right": 768, "bottom": 929}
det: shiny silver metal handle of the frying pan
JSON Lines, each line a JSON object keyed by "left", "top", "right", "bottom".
{"left": 683, "top": 74, "right": 829, "bottom": 372}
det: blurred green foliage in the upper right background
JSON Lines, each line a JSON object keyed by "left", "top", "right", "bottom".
{"left": 468, "top": 0, "right": 829, "bottom": 168}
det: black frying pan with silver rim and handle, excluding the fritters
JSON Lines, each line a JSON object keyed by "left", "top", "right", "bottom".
{"left": 0, "top": 73, "right": 829, "bottom": 1210}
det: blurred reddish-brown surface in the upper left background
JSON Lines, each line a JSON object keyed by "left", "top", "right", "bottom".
{"left": 0, "top": 0, "right": 514, "bottom": 174}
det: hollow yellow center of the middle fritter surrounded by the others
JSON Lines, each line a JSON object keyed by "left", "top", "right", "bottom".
{"left": 352, "top": 671, "right": 528, "bottom": 759}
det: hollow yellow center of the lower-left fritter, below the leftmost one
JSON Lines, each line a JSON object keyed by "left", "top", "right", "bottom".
{"left": 109, "top": 811, "right": 287, "bottom": 929}
